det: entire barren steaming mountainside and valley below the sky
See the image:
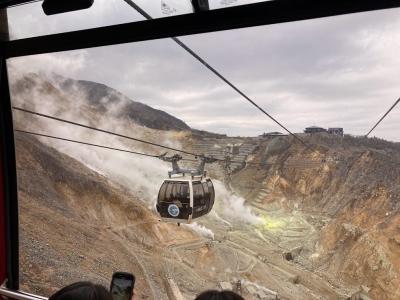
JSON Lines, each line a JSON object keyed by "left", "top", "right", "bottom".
{"left": 12, "top": 74, "right": 400, "bottom": 300}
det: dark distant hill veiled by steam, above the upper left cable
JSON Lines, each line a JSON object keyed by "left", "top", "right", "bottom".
{"left": 11, "top": 73, "right": 190, "bottom": 131}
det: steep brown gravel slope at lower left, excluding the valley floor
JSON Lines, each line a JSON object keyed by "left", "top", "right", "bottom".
{"left": 16, "top": 135, "right": 196, "bottom": 299}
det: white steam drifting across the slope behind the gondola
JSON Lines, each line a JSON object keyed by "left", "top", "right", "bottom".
{"left": 12, "top": 74, "right": 261, "bottom": 230}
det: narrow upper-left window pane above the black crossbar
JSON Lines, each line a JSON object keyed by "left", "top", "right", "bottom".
{"left": 7, "top": 0, "right": 192, "bottom": 39}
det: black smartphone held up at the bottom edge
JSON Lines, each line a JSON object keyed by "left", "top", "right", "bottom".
{"left": 110, "top": 272, "right": 135, "bottom": 300}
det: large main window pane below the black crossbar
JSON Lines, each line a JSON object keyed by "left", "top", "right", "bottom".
{"left": 7, "top": 7, "right": 400, "bottom": 300}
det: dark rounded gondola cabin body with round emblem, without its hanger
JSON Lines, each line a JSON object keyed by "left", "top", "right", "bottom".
{"left": 156, "top": 177, "right": 215, "bottom": 224}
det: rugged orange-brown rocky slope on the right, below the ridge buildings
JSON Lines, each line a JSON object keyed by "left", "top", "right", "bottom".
{"left": 234, "top": 135, "right": 400, "bottom": 299}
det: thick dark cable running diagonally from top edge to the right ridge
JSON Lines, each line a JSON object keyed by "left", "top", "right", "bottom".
{"left": 123, "top": 0, "right": 309, "bottom": 147}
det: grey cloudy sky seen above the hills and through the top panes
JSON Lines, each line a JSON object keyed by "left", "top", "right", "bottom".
{"left": 8, "top": 0, "right": 400, "bottom": 142}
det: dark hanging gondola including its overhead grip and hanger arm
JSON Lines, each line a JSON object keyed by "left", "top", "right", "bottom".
{"left": 156, "top": 155, "right": 216, "bottom": 225}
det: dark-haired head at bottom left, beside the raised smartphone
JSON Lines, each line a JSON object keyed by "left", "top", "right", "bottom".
{"left": 49, "top": 281, "right": 112, "bottom": 300}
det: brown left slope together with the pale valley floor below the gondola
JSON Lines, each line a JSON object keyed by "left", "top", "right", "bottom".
{"left": 16, "top": 134, "right": 350, "bottom": 300}
